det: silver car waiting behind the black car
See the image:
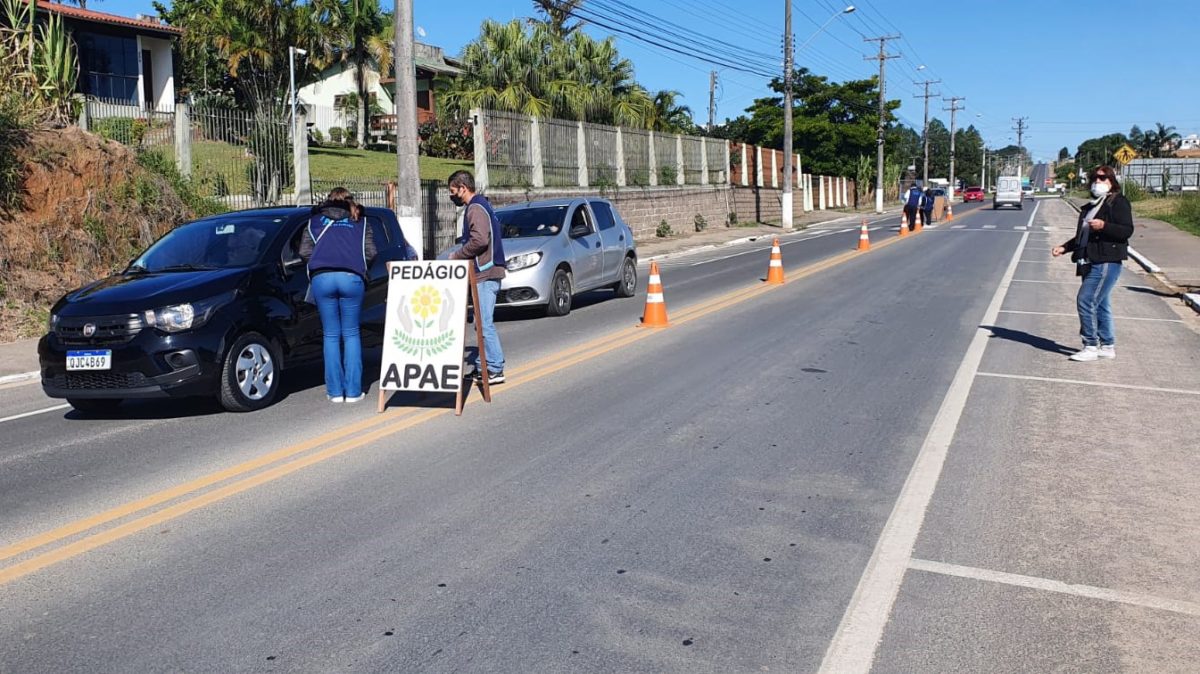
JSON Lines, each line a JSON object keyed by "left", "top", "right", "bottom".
{"left": 496, "top": 198, "right": 637, "bottom": 315}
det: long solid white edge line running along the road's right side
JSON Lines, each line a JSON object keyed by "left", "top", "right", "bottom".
{"left": 820, "top": 199, "right": 1038, "bottom": 674}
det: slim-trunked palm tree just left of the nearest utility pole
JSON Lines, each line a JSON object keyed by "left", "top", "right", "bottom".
{"left": 314, "top": 0, "right": 395, "bottom": 148}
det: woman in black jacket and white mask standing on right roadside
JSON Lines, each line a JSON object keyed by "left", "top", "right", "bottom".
{"left": 1050, "top": 166, "right": 1133, "bottom": 362}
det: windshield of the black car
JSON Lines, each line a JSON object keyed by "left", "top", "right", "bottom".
{"left": 127, "top": 212, "right": 284, "bottom": 272}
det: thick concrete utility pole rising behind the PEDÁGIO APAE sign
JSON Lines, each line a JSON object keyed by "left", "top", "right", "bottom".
{"left": 391, "top": 0, "right": 425, "bottom": 259}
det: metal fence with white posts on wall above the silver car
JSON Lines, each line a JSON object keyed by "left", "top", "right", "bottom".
{"left": 472, "top": 110, "right": 728, "bottom": 188}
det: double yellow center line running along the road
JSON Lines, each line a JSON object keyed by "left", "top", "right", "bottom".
{"left": 0, "top": 233, "right": 912, "bottom": 584}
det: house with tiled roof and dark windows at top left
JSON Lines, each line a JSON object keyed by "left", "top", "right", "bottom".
{"left": 37, "top": 2, "right": 184, "bottom": 112}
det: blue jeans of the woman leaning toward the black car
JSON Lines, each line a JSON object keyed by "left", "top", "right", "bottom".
{"left": 312, "top": 271, "right": 366, "bottom": 398}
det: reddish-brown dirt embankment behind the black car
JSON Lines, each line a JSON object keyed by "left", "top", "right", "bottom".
{"left": 0, "top": 127, "right": 191, "bottom": 342}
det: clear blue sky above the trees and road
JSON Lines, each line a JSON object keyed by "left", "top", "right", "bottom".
{"left": 98, "top": 0, "right": 1200, "bottom": 161}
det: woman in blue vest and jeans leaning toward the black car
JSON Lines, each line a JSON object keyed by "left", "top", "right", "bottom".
{"left": 300, "top": 187, "right": 376, "bottom": 403}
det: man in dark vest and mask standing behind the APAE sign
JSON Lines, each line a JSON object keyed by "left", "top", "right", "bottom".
{"left": 448, "top": 170, "right": 508, "bottom": 384}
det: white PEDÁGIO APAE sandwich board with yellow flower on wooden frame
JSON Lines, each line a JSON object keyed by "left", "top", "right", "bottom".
{"left": 378, "top": 260, "right": 491, "bottom": 414}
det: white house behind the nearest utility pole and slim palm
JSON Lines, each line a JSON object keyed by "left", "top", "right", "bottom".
{"left": 296, "top": 42, "right": 462, "bottom": 142}
